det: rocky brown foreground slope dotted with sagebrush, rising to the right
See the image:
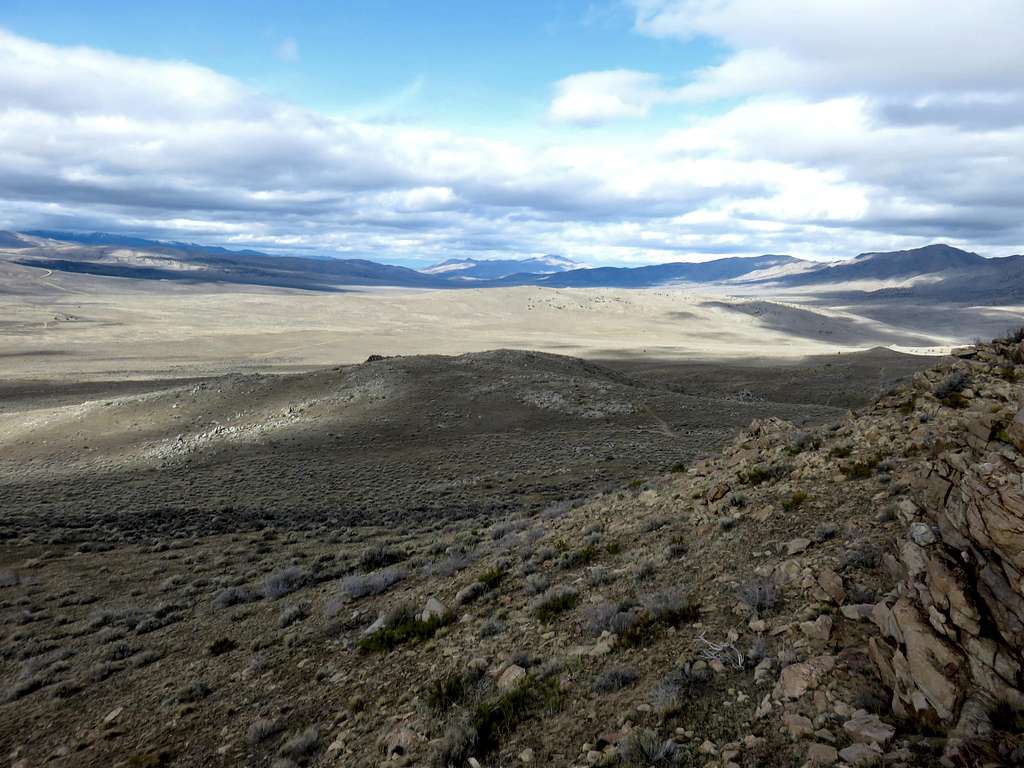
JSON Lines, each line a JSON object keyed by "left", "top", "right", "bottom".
{"left": 0, "top": 339, "right": 1024, "bottom": 768}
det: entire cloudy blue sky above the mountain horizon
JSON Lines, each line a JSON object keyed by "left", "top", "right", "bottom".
{"left": 0, "top": 0, "right": 1024, "bottom": 266}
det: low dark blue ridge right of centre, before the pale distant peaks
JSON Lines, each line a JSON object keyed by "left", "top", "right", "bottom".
{"left": 502, "top": 255, "right": 804, "bottom": 288}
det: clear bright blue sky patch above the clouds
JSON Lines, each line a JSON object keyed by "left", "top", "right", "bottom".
{"left": 0, "top": 0, "right": 721, "bottom": 133}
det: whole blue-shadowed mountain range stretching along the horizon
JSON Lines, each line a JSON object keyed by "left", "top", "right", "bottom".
{"left": 0, "top": 230, "right": 1024, "bottom": 303}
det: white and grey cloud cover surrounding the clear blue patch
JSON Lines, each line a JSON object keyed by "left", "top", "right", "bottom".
{"left": 0, "top": 0, "right": 1024, "bottom": 263}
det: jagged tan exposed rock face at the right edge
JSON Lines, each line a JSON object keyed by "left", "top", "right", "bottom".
{"left": 869, "top": 349, "right": 1024, "bottom": 760}
